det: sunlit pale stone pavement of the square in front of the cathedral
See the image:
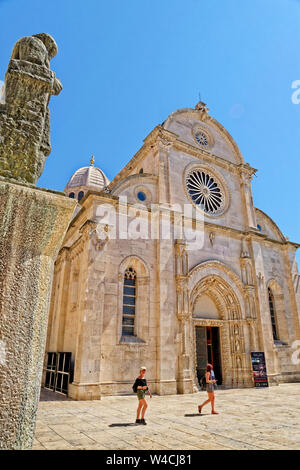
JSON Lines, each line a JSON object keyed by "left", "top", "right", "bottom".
{"left": 34, "top": 384, "right": 300, "bottom": 450}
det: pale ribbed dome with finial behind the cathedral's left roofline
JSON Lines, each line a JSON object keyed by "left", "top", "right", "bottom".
{"left": 65, "top": 158, "right": 109, "bottom": 201}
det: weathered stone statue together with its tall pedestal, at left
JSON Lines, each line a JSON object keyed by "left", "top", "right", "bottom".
{"left": 0, "top": 33, "right": 76, "bottom": 449}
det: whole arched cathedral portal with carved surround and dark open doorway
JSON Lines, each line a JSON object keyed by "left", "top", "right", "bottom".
{"left": 190, "top": 262, "right": 252, "bottom": 387}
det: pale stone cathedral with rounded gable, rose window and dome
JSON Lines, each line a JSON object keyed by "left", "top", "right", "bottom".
{"left": 43, "top": 102, "right": 300, "bottom": 399}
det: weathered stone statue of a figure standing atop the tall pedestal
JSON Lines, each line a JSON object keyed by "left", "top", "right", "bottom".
{"left": 0, "top": 33, "right": 62, "bottom": 185}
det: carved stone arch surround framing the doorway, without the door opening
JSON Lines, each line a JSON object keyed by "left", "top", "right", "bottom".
{"left": 189, "top": 261, "right": 252, "bottom": 387}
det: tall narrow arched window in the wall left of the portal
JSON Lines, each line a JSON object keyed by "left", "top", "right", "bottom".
{"left": 122, "top": 268, "right": 136, "bottom": 336}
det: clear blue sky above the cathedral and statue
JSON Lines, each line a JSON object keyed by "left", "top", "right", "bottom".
{"left": 0, "top": 0, "right": 300, "bottom": 258}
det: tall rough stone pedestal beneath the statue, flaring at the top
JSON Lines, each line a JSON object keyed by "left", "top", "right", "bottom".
{"left": 0, "top": 180, "right": 76, "bottom": 449}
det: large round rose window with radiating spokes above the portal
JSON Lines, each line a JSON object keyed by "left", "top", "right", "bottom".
{"left": 186, "top": 169, "right": 224, "bottom": 214}
